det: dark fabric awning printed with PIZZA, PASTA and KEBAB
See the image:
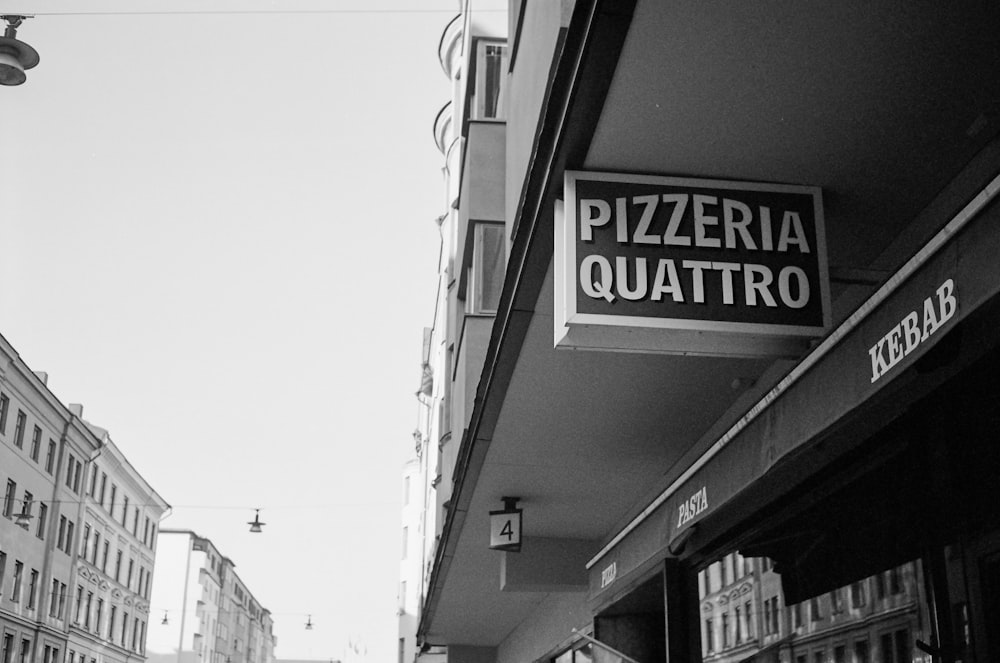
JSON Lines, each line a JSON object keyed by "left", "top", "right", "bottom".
{"left": 588, "top": 170, "right": 1000, "bottom": 600}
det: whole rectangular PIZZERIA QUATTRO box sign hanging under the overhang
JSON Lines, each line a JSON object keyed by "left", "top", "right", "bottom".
{"left": 555, "top": 171, "right": 829, "bottom": 356}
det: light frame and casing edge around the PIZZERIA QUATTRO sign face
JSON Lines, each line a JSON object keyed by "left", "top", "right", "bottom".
{"left": 553, "top": 170, "right": 832, "bottom": 356}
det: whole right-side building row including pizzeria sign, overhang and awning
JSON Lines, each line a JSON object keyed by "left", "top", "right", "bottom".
{"left": 400, "top": 0, "right": 1000, "bottom": 663}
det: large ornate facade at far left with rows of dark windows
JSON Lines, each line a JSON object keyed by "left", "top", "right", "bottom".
{"left": 0, "top": 337, "right": 168, "bottom": 663}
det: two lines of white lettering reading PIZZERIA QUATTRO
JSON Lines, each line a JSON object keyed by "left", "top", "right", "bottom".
{"left": 578, "top": 193, "right": 816, "bottom": 309}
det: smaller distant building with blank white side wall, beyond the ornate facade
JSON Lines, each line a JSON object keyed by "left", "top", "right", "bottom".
{"left": 148, "top": 529, "right": 277, "bottom": 663}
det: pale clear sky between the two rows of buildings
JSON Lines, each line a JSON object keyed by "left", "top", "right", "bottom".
{"left": 0, "top": 0, "right": 490, "bottom": 661}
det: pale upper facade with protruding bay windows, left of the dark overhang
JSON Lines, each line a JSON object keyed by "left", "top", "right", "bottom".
{"left": 398, "top": 10, "right": 507, "bottom": 663}
